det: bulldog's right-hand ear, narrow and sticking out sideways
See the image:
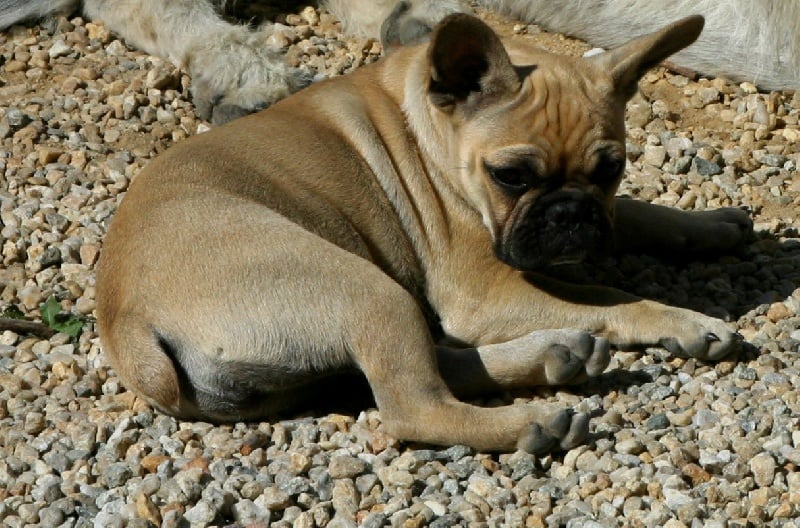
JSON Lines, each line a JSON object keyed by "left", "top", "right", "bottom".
{"left": 590, "top": 15, "right": 705, "bottom": 100}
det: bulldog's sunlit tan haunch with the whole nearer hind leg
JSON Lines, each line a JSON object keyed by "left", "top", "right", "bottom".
{"left": 97, "top": 196, "right": 588, "bottom": 453}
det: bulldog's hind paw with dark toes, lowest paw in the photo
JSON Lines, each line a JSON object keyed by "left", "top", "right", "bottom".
{"left": 517, "top": 409, "right": 589, "bottom": 455}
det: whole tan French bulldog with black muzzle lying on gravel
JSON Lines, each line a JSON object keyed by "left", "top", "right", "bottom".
{"left": 97, "top": 15, "right": 750, "bottom": 452}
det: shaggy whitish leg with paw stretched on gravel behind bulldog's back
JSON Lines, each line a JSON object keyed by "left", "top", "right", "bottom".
{"left": 84, "top": 0, "right": 310, "bottom": 124}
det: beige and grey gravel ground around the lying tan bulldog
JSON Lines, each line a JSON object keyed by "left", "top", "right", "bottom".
{"left": 0, "top": 5, "right": 800, "bottom": 528}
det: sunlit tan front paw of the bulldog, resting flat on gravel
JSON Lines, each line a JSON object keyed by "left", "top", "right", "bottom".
{"left": 659, "top": 313, "right": 742, "bottom": 360}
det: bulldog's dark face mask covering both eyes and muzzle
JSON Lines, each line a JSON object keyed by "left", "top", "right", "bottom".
{"left": 483, "top": 146, "right": 625, "bottom": 271}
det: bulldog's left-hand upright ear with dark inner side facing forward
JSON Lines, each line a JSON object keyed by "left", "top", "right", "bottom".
{"left": 428, "top": 13, "right": 521, "bottom": 111}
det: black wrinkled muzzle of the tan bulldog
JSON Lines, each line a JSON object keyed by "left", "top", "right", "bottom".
{"left": 495, "top": 190, "right": 613, "bottom": 271}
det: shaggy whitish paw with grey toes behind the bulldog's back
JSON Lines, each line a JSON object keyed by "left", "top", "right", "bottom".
{"left": 188, "top": 26, "right": 312, "bottom": 125}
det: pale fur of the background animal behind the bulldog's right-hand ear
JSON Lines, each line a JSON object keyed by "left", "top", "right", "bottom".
{"left": 480, "top": 0, "right": 800, "bottom": 90}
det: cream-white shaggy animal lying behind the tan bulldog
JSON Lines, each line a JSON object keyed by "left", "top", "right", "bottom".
{"left": 0, "top": 0, "right": 800, "bottom": 123}
